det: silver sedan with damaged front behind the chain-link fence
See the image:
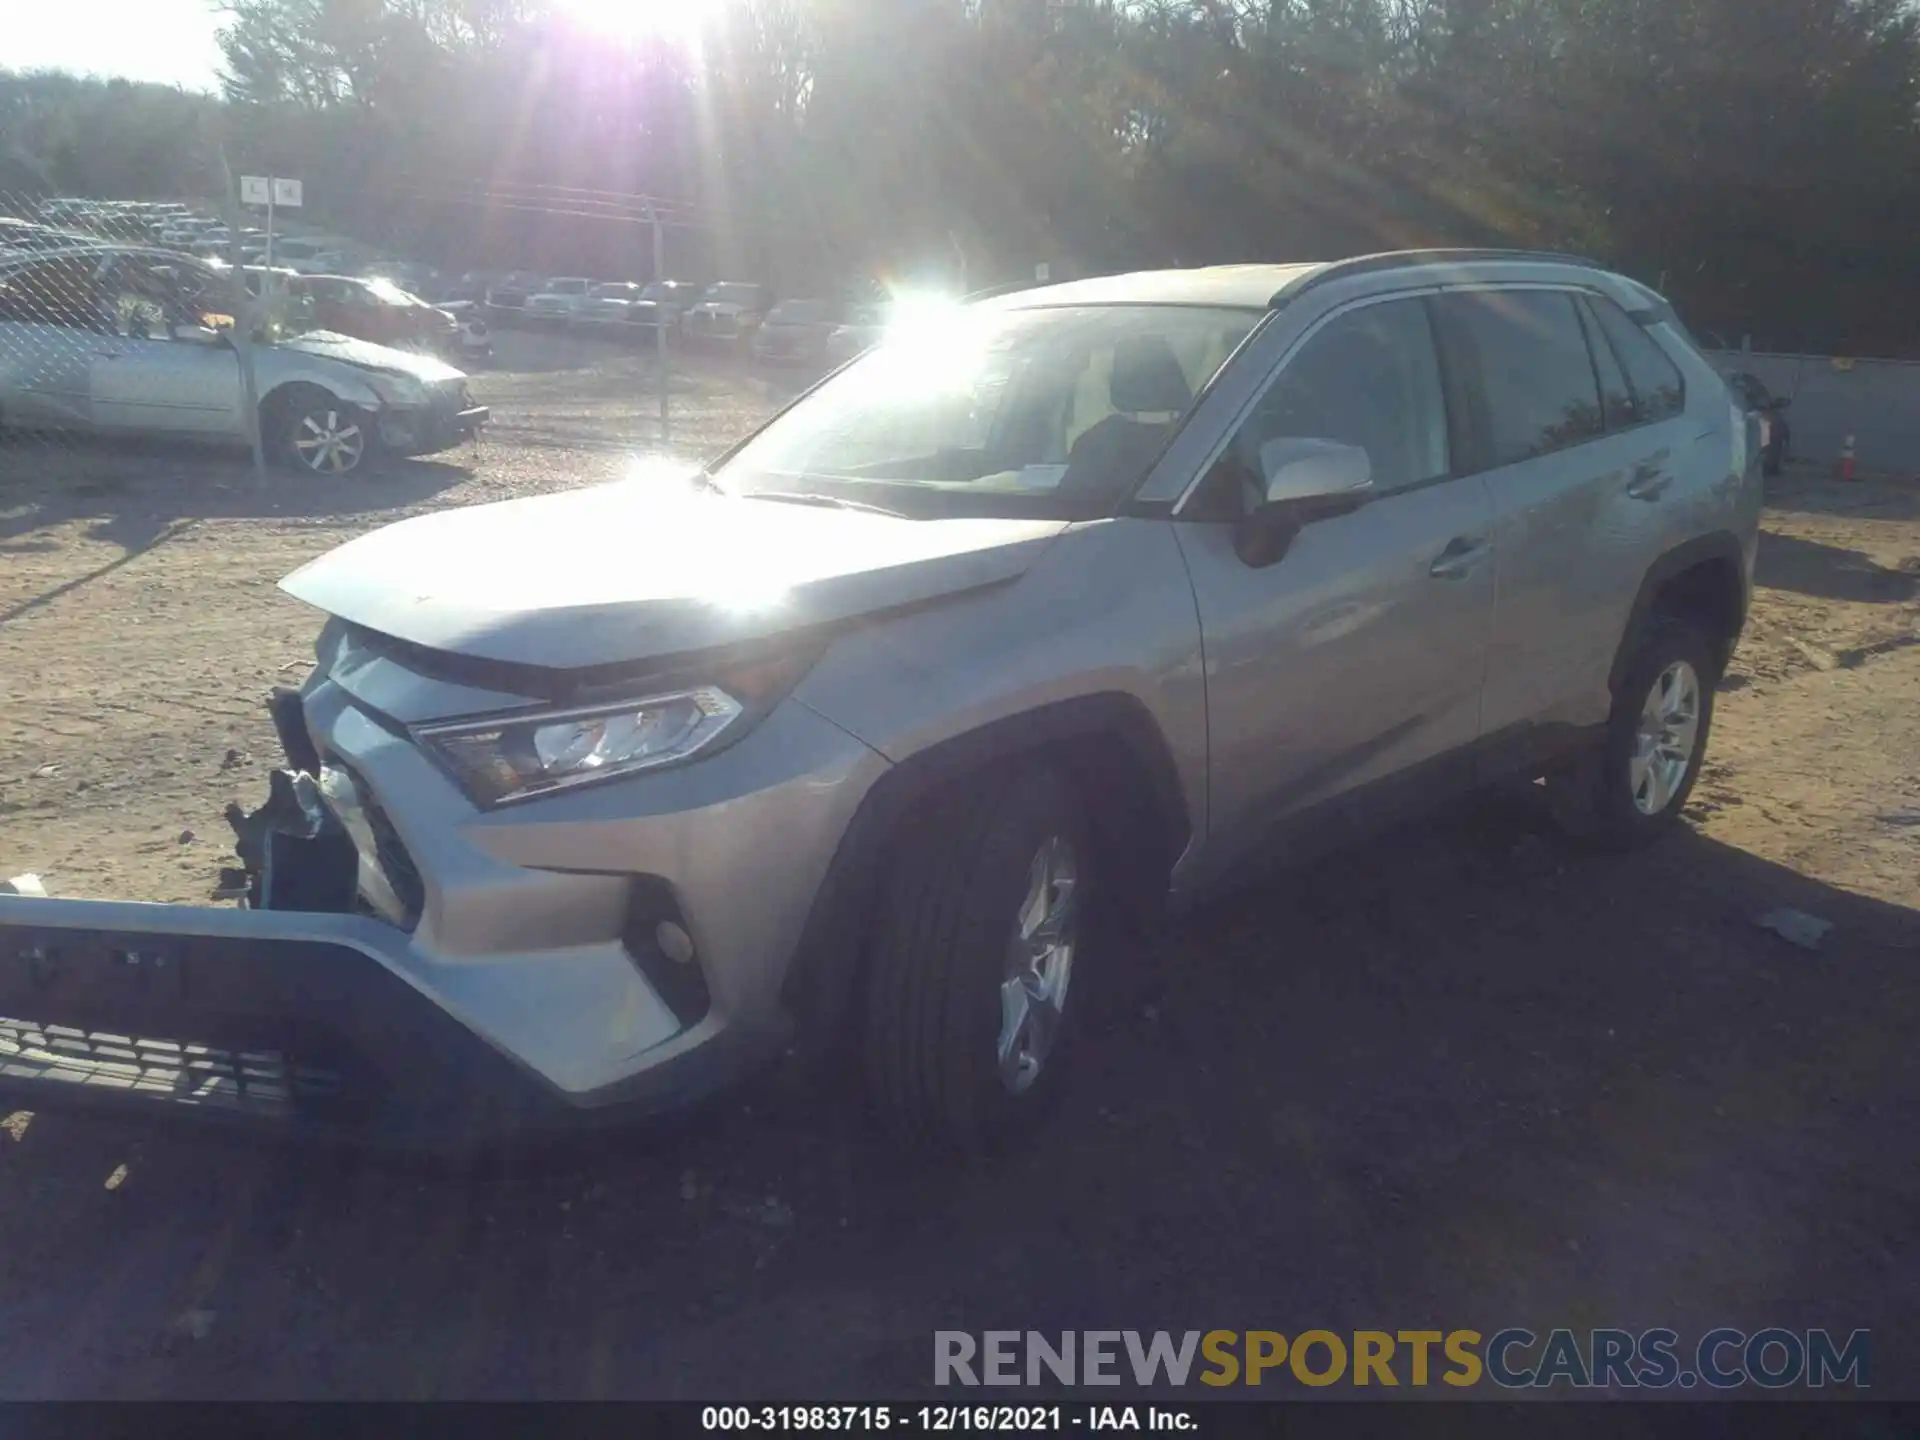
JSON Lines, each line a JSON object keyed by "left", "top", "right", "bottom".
{"left": 0, "top": 246, "right": 488, "bottom": 476}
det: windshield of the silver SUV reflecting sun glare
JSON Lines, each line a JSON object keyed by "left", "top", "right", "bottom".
{"left": 716, "top": 305, "right": 1261, "bottom": 518}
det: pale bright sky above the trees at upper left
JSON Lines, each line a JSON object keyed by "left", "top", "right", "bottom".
{"left": 0, "top": 0, "right": 221, "bottom": 90}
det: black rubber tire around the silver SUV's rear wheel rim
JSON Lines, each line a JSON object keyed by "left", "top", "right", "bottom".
{"left": 1548, "top": 618, "right": 1720, "bottom": 851}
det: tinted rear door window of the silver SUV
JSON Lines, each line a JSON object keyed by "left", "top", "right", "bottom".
{"left": 1436, "top": 290, "right": 1605, "bottom": 467}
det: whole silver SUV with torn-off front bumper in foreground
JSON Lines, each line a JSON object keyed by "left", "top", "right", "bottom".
{"left": 0, "top": 252, "right": 1761, "bottom": 1150}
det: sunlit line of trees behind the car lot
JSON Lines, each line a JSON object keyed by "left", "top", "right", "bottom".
{"left": 0, "top": 0, "right": 1920, "bottom": 357}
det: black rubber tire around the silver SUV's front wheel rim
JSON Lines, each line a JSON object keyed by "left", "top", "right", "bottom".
{"left": 862, "top": 764, "right": 1098, "bottom": 1156}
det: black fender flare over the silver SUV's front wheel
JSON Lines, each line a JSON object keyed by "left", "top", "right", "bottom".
{"left": 781, "top": 691, "right": 1192, "bottom": 1052}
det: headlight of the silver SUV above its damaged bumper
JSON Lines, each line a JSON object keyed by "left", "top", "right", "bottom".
{"left": 415, "top": 685, "right": 747, "bottom": 806}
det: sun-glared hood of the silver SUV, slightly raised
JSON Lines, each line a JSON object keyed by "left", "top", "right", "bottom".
{"left": 280, "top": 480, "right": 1066, "bottom": 670}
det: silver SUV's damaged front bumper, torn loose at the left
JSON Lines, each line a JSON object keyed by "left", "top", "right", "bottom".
{"left": 0, "top": 645, "right": 885, "bottom": 1150}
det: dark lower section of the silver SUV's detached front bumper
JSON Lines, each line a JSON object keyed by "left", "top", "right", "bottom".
{"left": 0, "top": 897, "right": 760, "bottom": 1152}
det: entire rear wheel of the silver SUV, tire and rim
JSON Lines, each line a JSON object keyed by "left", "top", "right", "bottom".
{"left": 1548, "top": 620, "right": 1720, "bottom": 849}
